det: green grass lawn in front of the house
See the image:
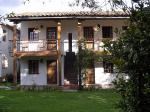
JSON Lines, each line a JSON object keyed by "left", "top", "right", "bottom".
{"left": 0, "top": 90, "right": 119, "bottom": 112}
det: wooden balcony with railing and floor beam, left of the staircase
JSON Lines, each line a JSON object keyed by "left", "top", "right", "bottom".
{"left": 15, "top": 39, "right": 57, "bottom": 58}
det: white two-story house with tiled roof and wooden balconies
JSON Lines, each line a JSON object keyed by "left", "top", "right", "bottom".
{"left": 8, "top": 12, "right": 128, "bottom": 87}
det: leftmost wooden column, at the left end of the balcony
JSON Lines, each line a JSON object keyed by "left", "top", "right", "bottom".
{"left": 13, "top": 25, "right": 17, "bottom": 84}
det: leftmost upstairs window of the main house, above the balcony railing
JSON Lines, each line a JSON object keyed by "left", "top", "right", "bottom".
{"left": 28, "top": 28, "right": 39, "bottom": 41}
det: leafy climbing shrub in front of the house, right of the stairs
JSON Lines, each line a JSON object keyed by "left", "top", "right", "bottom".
{"left": 76, "top": 39, "right": 102, "bottom": 90}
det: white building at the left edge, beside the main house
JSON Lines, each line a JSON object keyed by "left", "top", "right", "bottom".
{"left": 0, "top": 23, "right": 16, "bottom": 77}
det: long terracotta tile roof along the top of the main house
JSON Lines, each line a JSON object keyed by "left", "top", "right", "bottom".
{"left": 8, "top": 11, "right": 128, "bottom": 22}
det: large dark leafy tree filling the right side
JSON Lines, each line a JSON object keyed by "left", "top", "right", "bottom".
{"left": 105, "top": 1, "right": 150, "bottom": 112}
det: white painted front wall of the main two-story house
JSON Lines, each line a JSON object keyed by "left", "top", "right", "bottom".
{"left": 20, "top": 19, "right": 126, "bottom": 87}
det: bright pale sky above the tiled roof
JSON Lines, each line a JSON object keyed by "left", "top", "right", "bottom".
{"left": 0, "top": 0, "right": 130, "bottom": 15}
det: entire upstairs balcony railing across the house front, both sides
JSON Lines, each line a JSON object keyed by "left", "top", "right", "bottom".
{"left": 9, "top": 39, "right": 103, "bottom": 54}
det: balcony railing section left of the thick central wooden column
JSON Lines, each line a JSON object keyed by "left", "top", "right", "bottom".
{"left": 9, "top": 39, "right": 57, "bottom": 52}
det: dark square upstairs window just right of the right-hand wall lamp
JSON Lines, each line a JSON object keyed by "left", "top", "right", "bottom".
{"left": 102, "top": 26, "right": 113, "bottom": 38}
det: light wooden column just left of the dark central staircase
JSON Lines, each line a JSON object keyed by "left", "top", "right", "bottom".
{"left": 57, "top": 22, "right": 62, "bottom": 86}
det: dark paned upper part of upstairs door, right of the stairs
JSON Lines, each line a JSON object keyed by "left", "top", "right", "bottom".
{"left": 83, "top": 27, "right": 94, "bottom": 41}
